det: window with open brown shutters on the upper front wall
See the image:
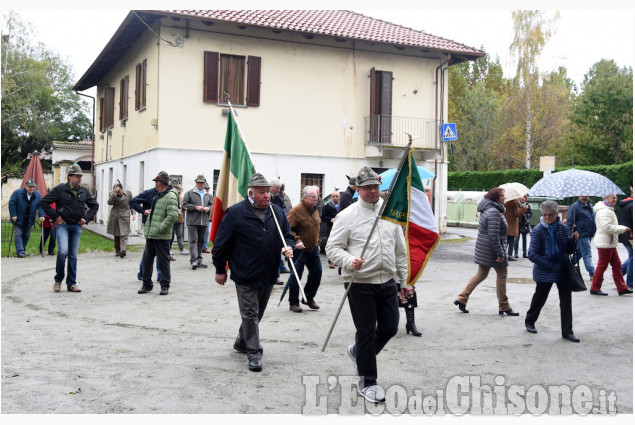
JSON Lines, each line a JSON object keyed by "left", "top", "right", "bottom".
{"left": 203, "top": 52, "right": 261, "bottom": 106}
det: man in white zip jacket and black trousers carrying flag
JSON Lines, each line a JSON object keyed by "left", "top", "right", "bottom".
{"left": 326, "top": 167, "right": 411, "bottom": 402}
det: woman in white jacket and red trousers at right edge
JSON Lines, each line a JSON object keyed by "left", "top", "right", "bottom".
{"left": 590, "top": 194, "right": 633, "bottom": 295}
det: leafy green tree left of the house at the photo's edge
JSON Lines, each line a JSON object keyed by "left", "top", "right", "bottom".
{"left": 2, "top": 11, "right": 92, "bottom": 173}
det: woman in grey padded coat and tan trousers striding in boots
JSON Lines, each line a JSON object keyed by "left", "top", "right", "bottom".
{"left": 454, "top": 187, "right": 518, "bottom": 316}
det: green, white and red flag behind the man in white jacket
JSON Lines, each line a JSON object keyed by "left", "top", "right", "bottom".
{"left": 381, "top": 148, "right": 441, "bottom": 286}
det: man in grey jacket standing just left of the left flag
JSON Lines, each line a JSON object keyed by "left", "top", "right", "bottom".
{"left": 181, "top": 174, "right": 214, "bottom": 270}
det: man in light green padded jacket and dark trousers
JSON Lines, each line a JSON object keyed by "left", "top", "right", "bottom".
{"left": 138, "top": 171, "right": 179, "bottom": 295}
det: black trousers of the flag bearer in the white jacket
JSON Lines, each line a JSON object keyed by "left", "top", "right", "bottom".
{"left": 348, "top": 279, "right": 399, "bottom": 387}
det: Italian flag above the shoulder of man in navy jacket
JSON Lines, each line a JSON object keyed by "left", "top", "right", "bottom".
{"left": 209, "top": 111, "right": 255, "bottom": 243}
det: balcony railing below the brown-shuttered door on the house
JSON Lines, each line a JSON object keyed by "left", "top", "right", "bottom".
{"left": 364, "top": 115, "right": 440, "bottom": 149}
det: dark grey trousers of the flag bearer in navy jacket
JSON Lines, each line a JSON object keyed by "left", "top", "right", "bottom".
{"left": 234, "top": 283, "right": 273, "bottom": 355}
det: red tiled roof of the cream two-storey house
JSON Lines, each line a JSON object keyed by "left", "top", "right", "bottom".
{"left": 73, "top": 10, "right": 485, "bottom": 90}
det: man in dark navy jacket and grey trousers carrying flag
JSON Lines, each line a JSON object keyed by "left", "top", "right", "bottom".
{"left": 212, "top": 173, "right": 295, "bottom": 372}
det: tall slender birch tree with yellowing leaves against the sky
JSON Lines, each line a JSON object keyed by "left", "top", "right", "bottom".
{"left": 509, "top": 10, "right": 560, "bottom": 168}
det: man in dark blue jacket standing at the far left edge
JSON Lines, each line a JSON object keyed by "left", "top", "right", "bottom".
{"left": 9, "top": 179, "right": 45, "bottom": 258}
